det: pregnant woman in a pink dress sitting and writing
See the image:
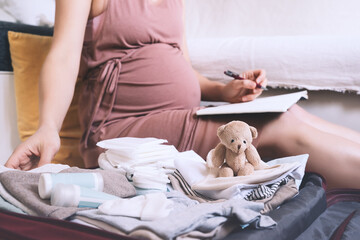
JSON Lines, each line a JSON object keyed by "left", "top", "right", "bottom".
{"left": 6, "top": 0, "right": 360, "bottom": 188}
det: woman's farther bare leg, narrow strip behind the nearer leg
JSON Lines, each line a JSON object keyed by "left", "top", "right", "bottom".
{"left": 291, "top": 105, "right": 360, "bottom": 144}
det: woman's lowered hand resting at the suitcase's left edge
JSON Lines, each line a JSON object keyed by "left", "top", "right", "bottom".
{"left": 5, "top": 127, "right": 60, "bottom": 171}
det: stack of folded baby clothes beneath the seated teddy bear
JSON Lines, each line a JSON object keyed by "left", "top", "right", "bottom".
{"left": 170, "top": 151, "right": 308, "bottom": 213}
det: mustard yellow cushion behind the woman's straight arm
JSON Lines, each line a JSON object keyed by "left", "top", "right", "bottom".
{"left": 8, "top": 31, "right": 84, "bottom": 167}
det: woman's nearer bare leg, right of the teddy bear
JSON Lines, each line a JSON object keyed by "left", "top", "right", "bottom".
{"left": 258, "top": 109, "right": 360, "bottom": 189}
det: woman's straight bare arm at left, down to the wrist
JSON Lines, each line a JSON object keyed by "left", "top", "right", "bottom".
{"left": 39, "top": 0, "right": 92, "bottom": 132}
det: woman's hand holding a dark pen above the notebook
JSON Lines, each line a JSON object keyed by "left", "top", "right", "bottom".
{"left": 222, "top": 69, "right": 267, "bottom": 103}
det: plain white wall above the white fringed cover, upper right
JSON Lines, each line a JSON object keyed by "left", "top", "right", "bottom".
{"left": 186, "top": 0, "right": 360, "bottom": 38}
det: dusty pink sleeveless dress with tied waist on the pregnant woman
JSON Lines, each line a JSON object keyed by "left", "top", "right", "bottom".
{"left": 79, "top": 0, "right": 262, "bottom": 168}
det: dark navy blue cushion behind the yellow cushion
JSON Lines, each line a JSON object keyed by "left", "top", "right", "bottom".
{"left": 0, "top": 21, "right": 53, "bottom": 71}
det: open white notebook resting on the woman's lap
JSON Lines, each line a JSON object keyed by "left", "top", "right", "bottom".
{"left": 196, "top": 91, "right": 308, "bottom": 115}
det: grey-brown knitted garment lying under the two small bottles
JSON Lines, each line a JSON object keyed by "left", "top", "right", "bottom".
{"left": 0, "top": 168, "right": 136, "bottom": 219}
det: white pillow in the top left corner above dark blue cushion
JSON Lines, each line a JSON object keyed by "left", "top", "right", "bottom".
{"left": 0, "top": 0, "right": 55, "bottom": 26}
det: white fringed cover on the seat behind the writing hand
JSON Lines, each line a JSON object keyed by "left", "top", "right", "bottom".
{"left": 188, "top": 36, "right": 360, "bottom": 93}
